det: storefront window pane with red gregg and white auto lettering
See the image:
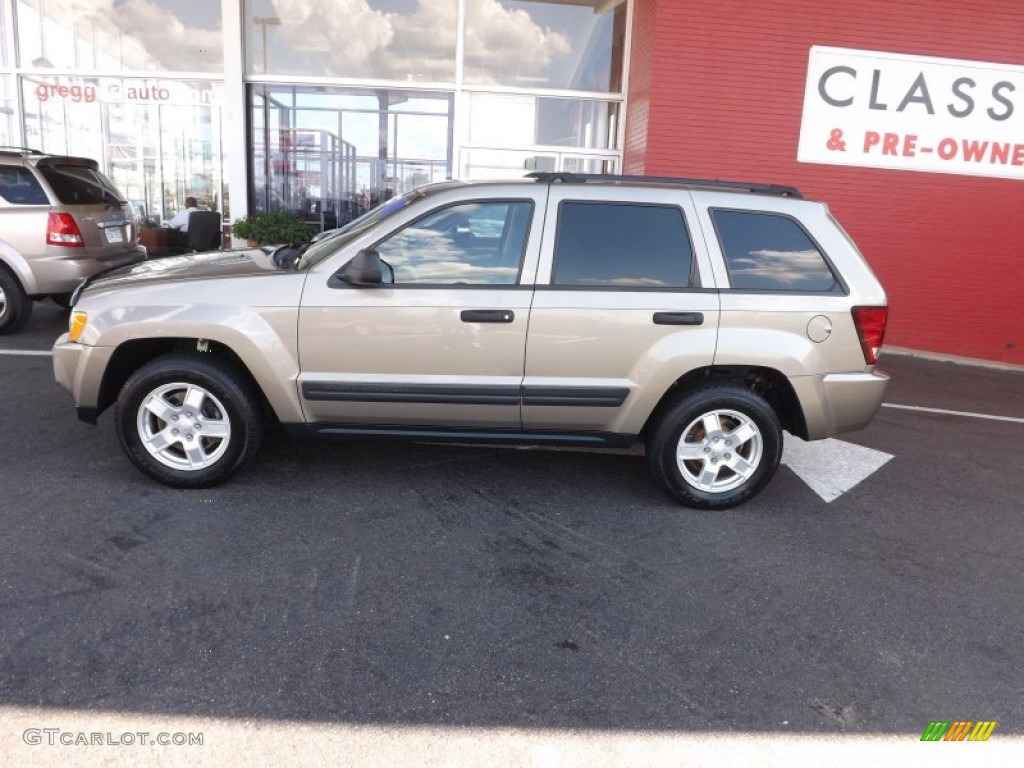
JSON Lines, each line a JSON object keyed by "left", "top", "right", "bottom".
{"left": 22, "top": 77, "right": 224, "bottom": 222}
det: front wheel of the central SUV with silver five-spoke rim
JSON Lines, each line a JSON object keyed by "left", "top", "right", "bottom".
{"left": 115, "top": 354, "right": 263, "bottom": 488}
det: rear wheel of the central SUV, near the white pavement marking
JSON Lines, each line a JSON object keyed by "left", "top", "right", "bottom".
{"left": 647, "top": 384, "right": 782, "bottom": 509}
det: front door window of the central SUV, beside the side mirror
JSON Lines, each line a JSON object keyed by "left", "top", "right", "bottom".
{"left": 377, "top": 201, "right": 534, "bottom": 285}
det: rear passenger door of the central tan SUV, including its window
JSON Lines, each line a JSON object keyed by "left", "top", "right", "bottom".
{"left": 522, "top": 183, "right": 719, "bottom": 434}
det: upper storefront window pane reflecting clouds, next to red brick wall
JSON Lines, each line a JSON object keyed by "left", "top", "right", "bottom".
{"left": 465, "top": 0, "right": 626, "bottom": 92}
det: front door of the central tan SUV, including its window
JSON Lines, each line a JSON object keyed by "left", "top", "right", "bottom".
{"left": 299, "top": 184, "right": 546, "bottom": 431}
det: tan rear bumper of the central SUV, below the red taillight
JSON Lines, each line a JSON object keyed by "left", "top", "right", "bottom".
{"left": 790, "top": 371, "right": 889, "bottom": 440}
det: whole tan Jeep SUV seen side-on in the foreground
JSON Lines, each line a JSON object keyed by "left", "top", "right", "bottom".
{"left": 53, "top": 174, "right": 888, "bottom": 509}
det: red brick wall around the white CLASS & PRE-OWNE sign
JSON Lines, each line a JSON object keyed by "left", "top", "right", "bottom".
{"left": 624, "top": 0, "right": 1024, "bottom": 365}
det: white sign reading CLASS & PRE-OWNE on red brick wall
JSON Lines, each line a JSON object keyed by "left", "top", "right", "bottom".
{"left": 797, "top": 46, "right": 1024, "bottom": 178}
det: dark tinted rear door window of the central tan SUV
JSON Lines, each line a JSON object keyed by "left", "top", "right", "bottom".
{"left": 551, "top": 203, "right": 693, "bottom": 288}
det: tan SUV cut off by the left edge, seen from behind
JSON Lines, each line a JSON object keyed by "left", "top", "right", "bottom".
{"left": 0, "top": 147, "right": 145, "bottom": 334}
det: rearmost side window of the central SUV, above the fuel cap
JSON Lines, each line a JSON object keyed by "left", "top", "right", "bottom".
{"left": 712, "top": 211, "right": 837, "bottom": 292}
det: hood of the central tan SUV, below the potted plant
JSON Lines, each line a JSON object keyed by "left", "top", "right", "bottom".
{"left": 88, "top": 248, "right": 284, "bottom": 289}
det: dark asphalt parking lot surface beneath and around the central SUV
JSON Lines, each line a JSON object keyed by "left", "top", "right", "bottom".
{"left": 0, "top": 305, "right": 1024, "bottom": 765}
